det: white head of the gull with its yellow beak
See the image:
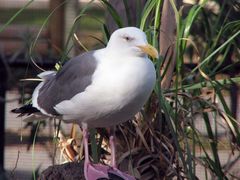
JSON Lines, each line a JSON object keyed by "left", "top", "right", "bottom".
{"left": 107, "top": 27, "right": 158, "bottom": 58}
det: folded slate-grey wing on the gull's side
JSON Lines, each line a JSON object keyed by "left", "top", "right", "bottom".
{"left": 37, "top": 51, "right": 97, "bottom": 115}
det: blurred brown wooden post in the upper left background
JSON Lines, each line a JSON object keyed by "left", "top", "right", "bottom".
{"left": 49, "top": 0, "right": 64, "bottom": 55}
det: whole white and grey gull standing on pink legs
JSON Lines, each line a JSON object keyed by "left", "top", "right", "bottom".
{"left": 13, "top": 27, "right": 158, "bottom": 180}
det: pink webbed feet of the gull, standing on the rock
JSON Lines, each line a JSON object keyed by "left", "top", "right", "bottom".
{"left": 85, "top": 164, "right": 135, "bottom": 180}
